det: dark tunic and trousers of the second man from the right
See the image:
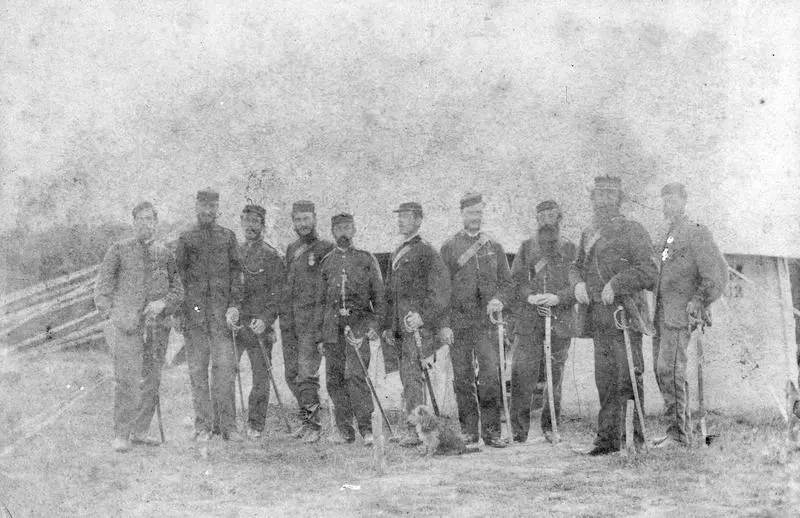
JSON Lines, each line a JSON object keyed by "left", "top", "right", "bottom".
{"left": 570, "top": 215, "right": 658, "bottom": 450}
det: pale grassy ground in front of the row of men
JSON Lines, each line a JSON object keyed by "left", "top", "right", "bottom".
{"left": 0, "top": 351, "right": 800, "bottom": 517}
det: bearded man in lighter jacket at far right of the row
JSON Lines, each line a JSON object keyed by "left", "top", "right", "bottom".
{"left": 653, "top": 183, "right": 728, "bottom": 447}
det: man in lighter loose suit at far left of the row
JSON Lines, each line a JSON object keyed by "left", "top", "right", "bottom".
{"left": 95, "top": 201, "right": 183, "bottom": 452}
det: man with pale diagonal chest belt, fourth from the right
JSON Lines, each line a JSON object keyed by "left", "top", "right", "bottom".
{"left": 441, "top": 193, "right": 512, "bottom": 448}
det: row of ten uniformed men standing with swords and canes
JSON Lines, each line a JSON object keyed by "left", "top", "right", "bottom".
{"left": 95, "top": 176, "right": 727, "bottom": 455}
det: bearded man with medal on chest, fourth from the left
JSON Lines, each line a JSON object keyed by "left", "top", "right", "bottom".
{"left": 281, "top": 200, "right": 333, "bottom": 443}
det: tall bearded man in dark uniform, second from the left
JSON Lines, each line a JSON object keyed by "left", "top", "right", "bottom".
{"left": 176, "top": 189, "right": 243, "bottom": 442}
